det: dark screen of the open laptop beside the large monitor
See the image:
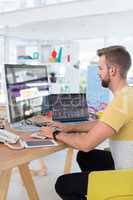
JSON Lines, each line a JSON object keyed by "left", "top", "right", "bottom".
{"left": 49, "top": 93, "right": 89, "bottom": 122}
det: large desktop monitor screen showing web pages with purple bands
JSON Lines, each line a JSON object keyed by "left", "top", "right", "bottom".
{"left": 5, "top": 64, "right": 49, "bottom": 123}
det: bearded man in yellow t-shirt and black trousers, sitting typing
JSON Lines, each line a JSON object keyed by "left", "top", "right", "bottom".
{"left": 39, "top": 46, "right": 133, "bottom": 200}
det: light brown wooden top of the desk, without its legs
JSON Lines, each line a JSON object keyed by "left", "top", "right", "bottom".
{"left": 0, "top": 131, "right": 67, "bottom": 170}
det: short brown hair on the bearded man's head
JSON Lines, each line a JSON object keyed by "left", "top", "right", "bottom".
{"left": 97, "top": 46, "right": 132, "bottom": 78}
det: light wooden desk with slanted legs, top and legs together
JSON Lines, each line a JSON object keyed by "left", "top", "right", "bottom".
{"left": 0, "top": 133, "right": 73, "bottom": 200}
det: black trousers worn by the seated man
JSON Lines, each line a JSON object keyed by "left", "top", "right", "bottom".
{"left": 55, "top": 150, "right": 114, "bottom": 200}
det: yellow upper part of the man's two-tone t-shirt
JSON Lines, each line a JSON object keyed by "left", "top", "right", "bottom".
{"left": 100, "top": 86, "right": 133, "bottom": 141}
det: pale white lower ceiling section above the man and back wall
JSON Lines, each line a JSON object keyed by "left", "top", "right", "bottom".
{"left": 0, "top": 0, "right": 133, "bottom": 40}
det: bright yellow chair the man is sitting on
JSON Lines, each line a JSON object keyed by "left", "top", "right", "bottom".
{"left": 87, "top": 169, "right": 133, "bottom": 200}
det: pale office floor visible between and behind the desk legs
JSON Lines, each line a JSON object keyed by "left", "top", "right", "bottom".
{"left": 7, "top": 141, "right": 108, "bottom": 200}
